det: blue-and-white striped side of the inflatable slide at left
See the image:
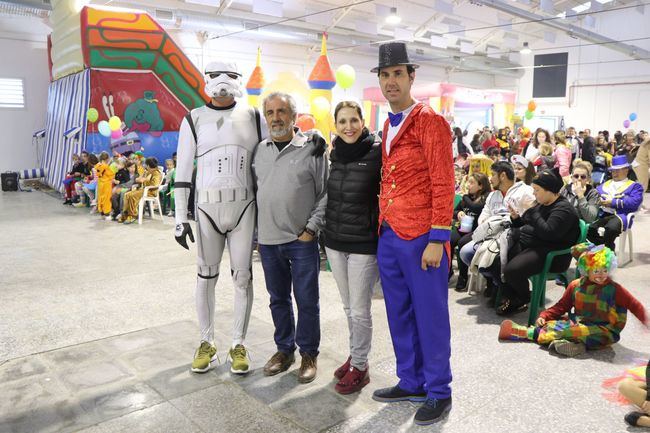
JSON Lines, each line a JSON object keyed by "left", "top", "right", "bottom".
{"left": 41, "top": 69, "right": 90, "bottom": 190}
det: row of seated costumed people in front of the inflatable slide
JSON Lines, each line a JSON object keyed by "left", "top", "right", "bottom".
{"left": 63, "top": 151, "right": 176, "bottom": 224}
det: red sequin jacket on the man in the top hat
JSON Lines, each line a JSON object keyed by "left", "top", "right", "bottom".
{"left": 379, "top": 103, "right": 454, "bottom": 242}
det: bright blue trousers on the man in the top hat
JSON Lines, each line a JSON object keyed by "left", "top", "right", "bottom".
{"left": 377, "top": 227, "right": 451, "bottom": 399}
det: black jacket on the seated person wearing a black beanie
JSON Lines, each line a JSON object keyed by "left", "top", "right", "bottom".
{"left": 512, "top": 196, "right": 580, "bottom": 251}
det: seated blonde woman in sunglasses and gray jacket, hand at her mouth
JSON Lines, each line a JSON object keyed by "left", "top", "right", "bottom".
{"left": 560, "top": 160, "right": 600, "bottom": 224}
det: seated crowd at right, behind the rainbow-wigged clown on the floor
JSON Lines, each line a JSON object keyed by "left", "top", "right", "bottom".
{"left": 449, "top": 123, "right": 650, "bottom": 316}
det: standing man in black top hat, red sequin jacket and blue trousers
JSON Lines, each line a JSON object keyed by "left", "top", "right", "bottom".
{"left": 371, "top": 42, "right": 454, "bottom": 425}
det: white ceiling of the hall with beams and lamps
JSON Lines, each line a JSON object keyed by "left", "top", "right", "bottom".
{"left": 0, "top": 0, "right": 636, "bottom": 76}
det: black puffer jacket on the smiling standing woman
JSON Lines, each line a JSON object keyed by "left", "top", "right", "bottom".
{"left": 325, "top": 135, "right": 381, "bottom": 254}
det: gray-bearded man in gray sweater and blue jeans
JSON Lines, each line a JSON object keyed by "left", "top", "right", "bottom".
{"left": 253, "top": 92, "right": 328, "bottom": 383}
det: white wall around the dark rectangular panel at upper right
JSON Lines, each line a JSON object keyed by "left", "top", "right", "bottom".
{"left": 518, "top": 9, "right": 650, "bottom": 132}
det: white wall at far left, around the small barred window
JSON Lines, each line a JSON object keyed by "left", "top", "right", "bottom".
{"left": 0, "top": 35, "right": 50, "bottom": 172}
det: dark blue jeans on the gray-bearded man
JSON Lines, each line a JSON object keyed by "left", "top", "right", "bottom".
{"left": 259, "top": 240, "right": 320, "bottom": 356}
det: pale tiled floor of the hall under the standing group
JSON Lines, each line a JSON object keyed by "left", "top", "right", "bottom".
{"left": 0, "top": 192, "right": 650, "bottom": 433}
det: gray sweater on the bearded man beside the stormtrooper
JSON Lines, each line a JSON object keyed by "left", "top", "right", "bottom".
{"left": 253, "top": 131, "right": 328, "bottom": 245}
